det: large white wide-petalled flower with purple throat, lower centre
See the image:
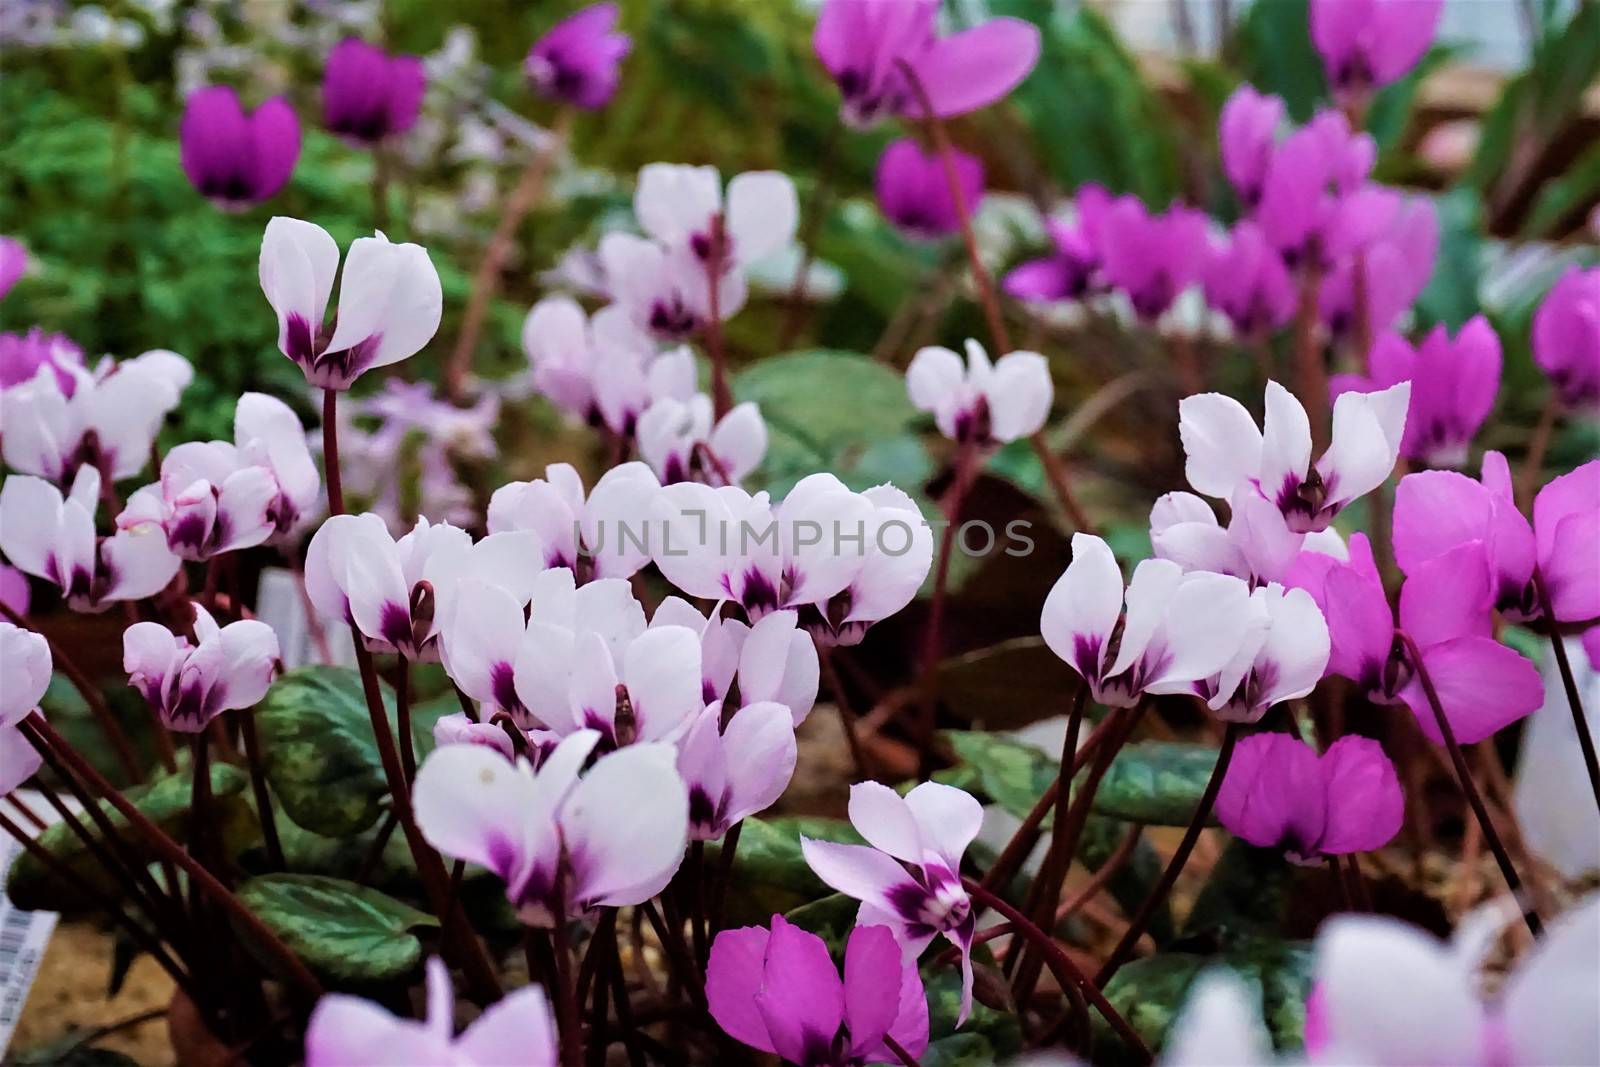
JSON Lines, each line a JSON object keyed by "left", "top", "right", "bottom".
{"left": 411, "top": 729, "right": 688, "bottom": 926}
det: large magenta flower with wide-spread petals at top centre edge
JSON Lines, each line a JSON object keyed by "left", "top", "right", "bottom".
{"left": 811, "top": 0, "right": 1038, "bottom": 126}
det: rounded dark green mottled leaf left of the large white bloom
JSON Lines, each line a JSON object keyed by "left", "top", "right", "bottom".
{"left": 256, "top": 667, "right": 412, "bottom": 837}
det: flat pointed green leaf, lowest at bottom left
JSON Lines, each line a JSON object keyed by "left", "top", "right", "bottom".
{"left": 238, "top": 875, "right": 438, "bottom": 984}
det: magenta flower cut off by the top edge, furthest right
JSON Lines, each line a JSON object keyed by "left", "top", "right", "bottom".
{"left": 1310, "top": 0, "right": 1445, "bottom": 96}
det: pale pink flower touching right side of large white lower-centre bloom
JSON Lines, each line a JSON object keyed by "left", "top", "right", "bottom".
{"left": 678, "top": 701, "right": 797, "bottom": 841}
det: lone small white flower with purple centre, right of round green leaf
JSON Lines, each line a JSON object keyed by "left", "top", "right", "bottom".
{"left": 906, "top": 339, "right": 1054, "bottom": 445}
